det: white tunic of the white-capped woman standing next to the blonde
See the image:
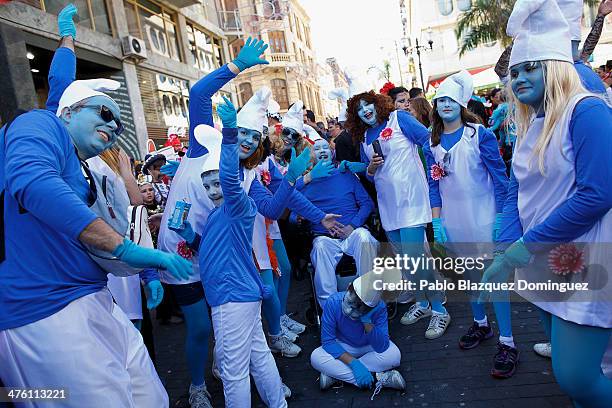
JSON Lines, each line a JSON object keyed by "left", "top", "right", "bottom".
{"left": 430, "top": 124, "right": 496, "bottom": 258}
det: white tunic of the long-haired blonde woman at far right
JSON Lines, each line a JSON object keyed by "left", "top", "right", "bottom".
{"left": 512, "top": 95, "right": 612, "bottom": 328}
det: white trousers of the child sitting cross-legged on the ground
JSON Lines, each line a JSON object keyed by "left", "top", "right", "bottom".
{"left": 310, "top": 341, "right": 402, "bottom": 385}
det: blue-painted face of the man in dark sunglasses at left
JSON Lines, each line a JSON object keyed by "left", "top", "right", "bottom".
{"left": 61, "top": 96, "right": 121, "bottom": 160}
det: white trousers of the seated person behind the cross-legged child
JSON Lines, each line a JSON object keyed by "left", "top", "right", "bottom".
{"left": 310, "top": 227, "right": 379, "bottom": 308}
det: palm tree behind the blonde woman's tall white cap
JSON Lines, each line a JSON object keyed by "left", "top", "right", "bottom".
{"left": 455, "top": 0, "right": 599, "bottom": 56}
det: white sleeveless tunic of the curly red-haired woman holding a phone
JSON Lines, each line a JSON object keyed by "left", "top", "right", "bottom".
{"left": 362, "top": 112, "right": 431, "bottom": 231}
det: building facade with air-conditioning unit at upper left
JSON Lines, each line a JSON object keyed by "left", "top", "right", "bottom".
{"left": 0, "top": 0, "right": 242, "bottom": 158}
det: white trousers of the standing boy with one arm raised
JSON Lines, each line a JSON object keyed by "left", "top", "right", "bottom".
{"left": 212, "top": 302, "right": 287, "bottom": 408}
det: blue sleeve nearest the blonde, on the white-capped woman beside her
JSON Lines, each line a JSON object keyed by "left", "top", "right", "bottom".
{"left": 478, "top": 127, "right": 508, "bottom": 213}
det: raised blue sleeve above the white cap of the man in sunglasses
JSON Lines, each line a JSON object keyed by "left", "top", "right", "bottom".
{"left": 46, "top": 47, "right": 76, "bottom": 114}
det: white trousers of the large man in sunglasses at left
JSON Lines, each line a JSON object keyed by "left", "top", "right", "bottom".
{"left": 0, "top": 288, "right": 168, "bottom": 408}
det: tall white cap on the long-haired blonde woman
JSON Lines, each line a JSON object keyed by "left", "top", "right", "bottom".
{"left": 506, "top": 0, "right": 574, "bottom": 67}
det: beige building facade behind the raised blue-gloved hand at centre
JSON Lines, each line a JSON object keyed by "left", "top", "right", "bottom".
{"left": 225, "top": 0, "right": 326, "bottom": 121}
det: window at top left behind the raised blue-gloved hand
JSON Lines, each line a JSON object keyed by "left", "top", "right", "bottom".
{"left": 20, "top": 0, "right": 113, "bottom": 35}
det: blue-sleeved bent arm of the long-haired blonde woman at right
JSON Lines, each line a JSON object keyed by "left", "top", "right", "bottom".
{"left": 523, "top": 98, "right": 612, "bottom": 247}
